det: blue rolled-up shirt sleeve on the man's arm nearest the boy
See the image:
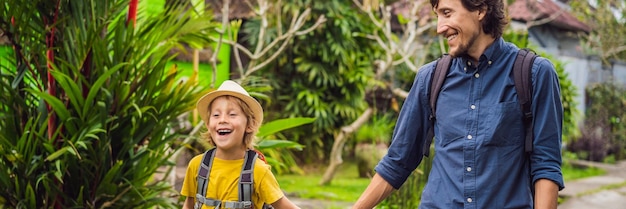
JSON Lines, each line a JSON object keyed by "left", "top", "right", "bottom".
{"left": 375, "top": 62, "right": 435, "bottom": 189}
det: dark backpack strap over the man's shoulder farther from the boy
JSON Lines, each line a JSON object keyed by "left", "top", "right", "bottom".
{"left": 513, "top": 48, "right": 537, "bottom": 152}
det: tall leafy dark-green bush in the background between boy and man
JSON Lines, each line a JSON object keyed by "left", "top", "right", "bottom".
{"left": 244, "top": 0, "right": 380, "bottom": 161}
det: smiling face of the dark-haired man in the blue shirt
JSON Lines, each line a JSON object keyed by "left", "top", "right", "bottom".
{"left": 434, "top": 0, "right": 490, "bottom": 57}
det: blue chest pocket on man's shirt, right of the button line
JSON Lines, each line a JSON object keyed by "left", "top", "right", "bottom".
{"left": 482, "top": 101, "right": 524, "bottom": 147}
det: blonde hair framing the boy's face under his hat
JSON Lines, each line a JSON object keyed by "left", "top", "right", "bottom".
{"left": 202, "top": 95, "right": 260, "bottom": 149}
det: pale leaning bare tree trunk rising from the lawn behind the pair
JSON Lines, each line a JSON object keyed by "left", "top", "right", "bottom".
{"left": 320, "top": 107, "right": 374, "bottom": 185}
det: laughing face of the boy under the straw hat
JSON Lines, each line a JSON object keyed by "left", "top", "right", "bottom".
{"left": 207, "top": 96, "right": 252, "bottom": 152}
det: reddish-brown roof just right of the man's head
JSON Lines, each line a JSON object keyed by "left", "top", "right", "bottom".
{"left": 508, "top": 0, "right": 591, "bottom": 32}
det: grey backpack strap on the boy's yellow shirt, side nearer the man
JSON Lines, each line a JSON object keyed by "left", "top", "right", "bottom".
{"left": 239, "top": 150, "right": 258, "bottom": 208}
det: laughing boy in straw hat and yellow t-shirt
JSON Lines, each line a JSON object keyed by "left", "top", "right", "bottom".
{"left": 181, "top": 81, "right": 298, "bottom": 209}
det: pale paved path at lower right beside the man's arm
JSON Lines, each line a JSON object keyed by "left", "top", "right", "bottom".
{"left": 558, "top": 161, "right": 626, "bottom": 209}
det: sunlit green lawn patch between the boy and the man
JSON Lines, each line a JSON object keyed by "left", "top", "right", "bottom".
{"left": 276, "top": 162, "right": 370, "bottom": 202}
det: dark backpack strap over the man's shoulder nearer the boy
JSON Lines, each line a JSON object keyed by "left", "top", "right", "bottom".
{"left": 424, "top": 54, "right": 452, "bottom": 157}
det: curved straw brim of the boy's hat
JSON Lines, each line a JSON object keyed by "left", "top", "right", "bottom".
{"left": 196, "top": 90, "right": 263, "bottom": 128}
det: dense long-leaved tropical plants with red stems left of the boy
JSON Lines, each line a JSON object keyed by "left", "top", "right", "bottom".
{"left": 0, "top": 0, "right": 215, "bottom": 208}
